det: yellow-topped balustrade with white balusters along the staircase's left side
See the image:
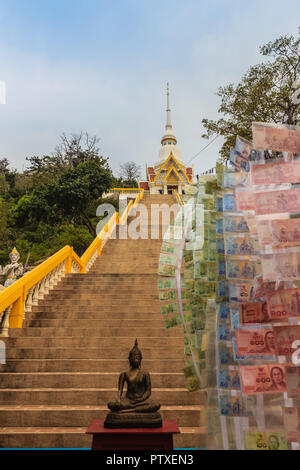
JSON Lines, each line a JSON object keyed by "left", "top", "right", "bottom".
{"left": 0, "top": 188, "right": 144, "bottom": 336}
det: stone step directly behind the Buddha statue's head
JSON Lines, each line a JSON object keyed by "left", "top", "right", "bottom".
{"left": 6, "top": 345, "right": 184, "bottom": 360}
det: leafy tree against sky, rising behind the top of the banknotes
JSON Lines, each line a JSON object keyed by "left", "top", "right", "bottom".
{"left": 202, "top": 27, "right": 300, "bottom": 160}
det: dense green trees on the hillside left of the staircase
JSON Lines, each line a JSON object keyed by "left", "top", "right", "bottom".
{"left": 0, "top": 133, "right": 118, "bottom": 265}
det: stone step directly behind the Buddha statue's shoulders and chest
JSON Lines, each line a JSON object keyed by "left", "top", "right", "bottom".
{"left": 0, "top": 372, "right": 185, "bottom": 390}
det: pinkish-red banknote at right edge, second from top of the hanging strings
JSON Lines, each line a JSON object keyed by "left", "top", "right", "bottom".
{"left": 251, "top": 161, "right": 300, "bottom": 185}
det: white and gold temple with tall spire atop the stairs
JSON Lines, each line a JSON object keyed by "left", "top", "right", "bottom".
{"left": 139, "top": 85, "right": 194, "bottom": 194}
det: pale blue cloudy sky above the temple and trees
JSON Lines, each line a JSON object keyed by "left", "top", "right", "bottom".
{"left": 0, "top": 0, "right": 300, "bottom": 177}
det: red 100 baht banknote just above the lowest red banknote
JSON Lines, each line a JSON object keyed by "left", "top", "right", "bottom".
{"left": 235, "top": 328, "right": 275, "bottom": 356}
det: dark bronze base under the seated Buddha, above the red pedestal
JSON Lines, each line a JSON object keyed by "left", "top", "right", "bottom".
{"left": 104, "top": 411, "right": 162, "bottom": 428}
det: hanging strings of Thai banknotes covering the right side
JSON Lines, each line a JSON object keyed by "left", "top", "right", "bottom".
{"left": 159, "top": 123, "right": 300, "bottom": 450}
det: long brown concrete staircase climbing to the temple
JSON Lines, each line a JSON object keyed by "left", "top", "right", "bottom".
{"left": 0, "top": 195, "right": 204, "bottom": 448}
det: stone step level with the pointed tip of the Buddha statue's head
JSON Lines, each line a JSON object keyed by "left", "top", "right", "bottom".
{"left": 3, "top": 336, "right": 184, "bottom": 348}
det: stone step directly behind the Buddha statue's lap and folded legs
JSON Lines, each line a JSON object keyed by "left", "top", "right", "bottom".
{"left": 0, "top": 388, "right": 205, "bottom": 407}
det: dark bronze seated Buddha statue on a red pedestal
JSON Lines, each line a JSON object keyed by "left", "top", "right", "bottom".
{"left": 104, "top": 340, "right": 162, "bottom": 427}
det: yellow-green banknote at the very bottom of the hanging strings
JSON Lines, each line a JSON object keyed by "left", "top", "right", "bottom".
{"left": 244, "top": 431, "right": 288, "bottom": 450}
